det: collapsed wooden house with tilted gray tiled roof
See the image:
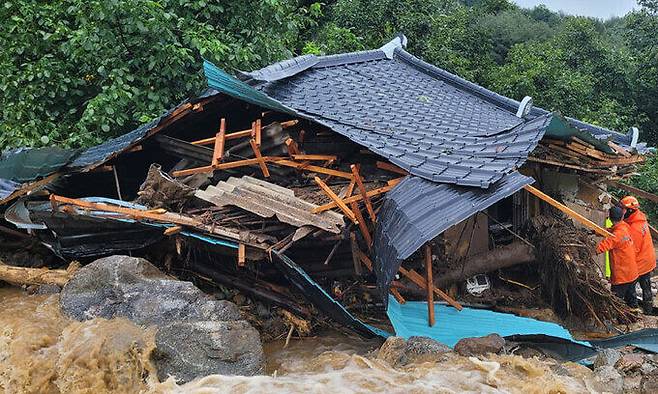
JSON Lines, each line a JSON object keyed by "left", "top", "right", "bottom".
{"left": 0, "top": 36, "right": 649, "bottom": 344}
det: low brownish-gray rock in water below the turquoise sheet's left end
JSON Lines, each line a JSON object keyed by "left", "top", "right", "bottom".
{"left": 377, "top": 337, "right": 452, "bottom": 366}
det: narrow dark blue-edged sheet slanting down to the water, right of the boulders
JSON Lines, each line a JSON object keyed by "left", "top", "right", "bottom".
{"left": 272, "top": 251, "right": 390, "bottom": 338}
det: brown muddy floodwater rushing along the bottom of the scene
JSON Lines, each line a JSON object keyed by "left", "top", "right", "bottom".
{"left": 0, "top": 288, "right": 596, "bottom": 394}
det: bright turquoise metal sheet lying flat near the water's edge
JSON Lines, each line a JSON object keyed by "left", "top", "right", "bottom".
{"left": 387, "top": 296, "right": 589, "bottom": 347}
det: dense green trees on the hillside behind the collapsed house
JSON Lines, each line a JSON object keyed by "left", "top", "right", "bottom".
{"left": 0, "top": 0, "right": 658, "bottom": 149}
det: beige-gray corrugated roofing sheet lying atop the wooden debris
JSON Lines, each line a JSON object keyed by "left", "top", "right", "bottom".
{"left": 195, "top": 176, "right": 345, "bottom": 234}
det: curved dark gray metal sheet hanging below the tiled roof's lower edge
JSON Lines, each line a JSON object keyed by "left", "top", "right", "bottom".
{"left": 374, "top": 172, "right": 534, "bottom": 299}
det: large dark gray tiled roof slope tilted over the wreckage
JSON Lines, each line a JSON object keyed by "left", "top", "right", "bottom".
{"left": 245, "top": 40, "right": 550, "bottom": 188}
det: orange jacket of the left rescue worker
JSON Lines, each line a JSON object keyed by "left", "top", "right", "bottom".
{"left": 596, "top": 221, "right": 639, "bottom": 285}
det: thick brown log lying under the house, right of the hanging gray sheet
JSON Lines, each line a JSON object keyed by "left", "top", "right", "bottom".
{"left": 434, "top": 242, "right": 535, "bottom": 288}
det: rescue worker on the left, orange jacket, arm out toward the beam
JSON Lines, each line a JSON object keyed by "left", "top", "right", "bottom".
{"left": 596, "top": 206, "right": 638, "bottom": 309}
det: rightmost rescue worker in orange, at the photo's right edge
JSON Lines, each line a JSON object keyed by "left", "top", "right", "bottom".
{"left": 620, "top": 196, "right": 656, "bottom": 314}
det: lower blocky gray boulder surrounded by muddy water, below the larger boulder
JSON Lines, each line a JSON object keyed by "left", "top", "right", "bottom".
{"left": 151, "top": 320, "right": 265, "bottom": 382}
